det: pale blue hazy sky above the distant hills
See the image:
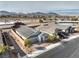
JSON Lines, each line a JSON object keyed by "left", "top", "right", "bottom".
{"left": 0, "top": 1, "right": 79, "bottom": 13}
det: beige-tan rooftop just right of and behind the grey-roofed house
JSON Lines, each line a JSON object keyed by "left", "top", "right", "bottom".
{"left": 36, "top": 22, "right": 57, "bottom": 34}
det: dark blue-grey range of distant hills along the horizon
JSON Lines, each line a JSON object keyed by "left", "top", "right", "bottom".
{"left": 0, "top": 11, "right": 58, "bottom": 16}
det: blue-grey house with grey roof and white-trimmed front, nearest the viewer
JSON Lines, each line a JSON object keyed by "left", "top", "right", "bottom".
{"left": 15, "top": 26, "right": 47, "bottom": 43}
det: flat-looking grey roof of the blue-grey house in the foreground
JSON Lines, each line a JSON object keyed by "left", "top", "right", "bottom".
{"left": 16, "top": 26, "right": 39, "bottom": 38}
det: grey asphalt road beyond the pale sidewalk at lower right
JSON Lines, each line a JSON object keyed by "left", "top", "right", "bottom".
{"left": 37, "top": 38, "right": 79, "bottom": 58}
